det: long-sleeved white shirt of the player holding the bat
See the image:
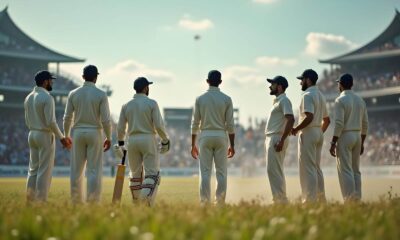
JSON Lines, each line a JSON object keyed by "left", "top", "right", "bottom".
{"left": 117, "top": 93, "right": 168, "bottom": 141}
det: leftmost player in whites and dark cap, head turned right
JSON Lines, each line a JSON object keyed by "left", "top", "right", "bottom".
{"left": 24, "top": 71, "right": 71, "bottom": 202}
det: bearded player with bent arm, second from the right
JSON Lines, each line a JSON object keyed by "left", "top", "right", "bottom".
{"left": 292, "top": 69, "right": 330, "bottom": 202}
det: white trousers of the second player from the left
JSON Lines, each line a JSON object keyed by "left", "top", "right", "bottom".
{"left": 71, "top": 128, "right": 103, "bottom": 203}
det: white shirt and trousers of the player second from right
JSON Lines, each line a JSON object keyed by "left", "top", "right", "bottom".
{"left": 298, "top": 86, "right": 328, "bottom": 201}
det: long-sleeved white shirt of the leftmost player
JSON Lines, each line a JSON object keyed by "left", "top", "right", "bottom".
{"left": 24, "top": 87, "right": 64, "bottom": 139}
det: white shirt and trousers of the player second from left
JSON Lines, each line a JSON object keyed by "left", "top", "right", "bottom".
{"left": 64, "top": 81, "right": 111, "bottom": 202}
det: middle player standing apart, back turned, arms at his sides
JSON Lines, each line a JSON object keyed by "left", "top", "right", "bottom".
{"left": 191, "top": 70, "right": 235, "bottom": 205}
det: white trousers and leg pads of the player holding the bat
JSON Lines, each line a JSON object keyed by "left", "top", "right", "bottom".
{"left": 128, "top": 134, "right": 160, "bottom": 202}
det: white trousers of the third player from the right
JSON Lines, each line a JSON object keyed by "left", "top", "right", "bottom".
{"left": 265, "top": 134, "right": 289, "bottom": 203}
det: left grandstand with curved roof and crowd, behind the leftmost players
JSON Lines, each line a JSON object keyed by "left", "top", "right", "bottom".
{"left": 0, "top": 7, "right": 111, "bottom": 166}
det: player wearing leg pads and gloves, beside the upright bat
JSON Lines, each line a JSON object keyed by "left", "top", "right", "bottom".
{"left": 117, "top": 77, "right": 170, "bottom": 206}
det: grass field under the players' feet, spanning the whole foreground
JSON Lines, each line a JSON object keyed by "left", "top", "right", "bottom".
{"left": 0, "top": 177, "right": 400, "bottom": 240}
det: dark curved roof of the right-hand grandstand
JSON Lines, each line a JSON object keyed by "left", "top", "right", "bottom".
{"left": 319, "top": 10, "right": 400, "bottom": 64}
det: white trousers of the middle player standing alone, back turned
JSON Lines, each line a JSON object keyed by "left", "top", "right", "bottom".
{"left": 199, "top": 136, "right": 228, "bottom": 203}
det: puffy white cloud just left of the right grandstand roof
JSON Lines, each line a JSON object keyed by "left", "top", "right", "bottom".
{"left": 305, "top": 32, "right": 357, "bottom": 57}
